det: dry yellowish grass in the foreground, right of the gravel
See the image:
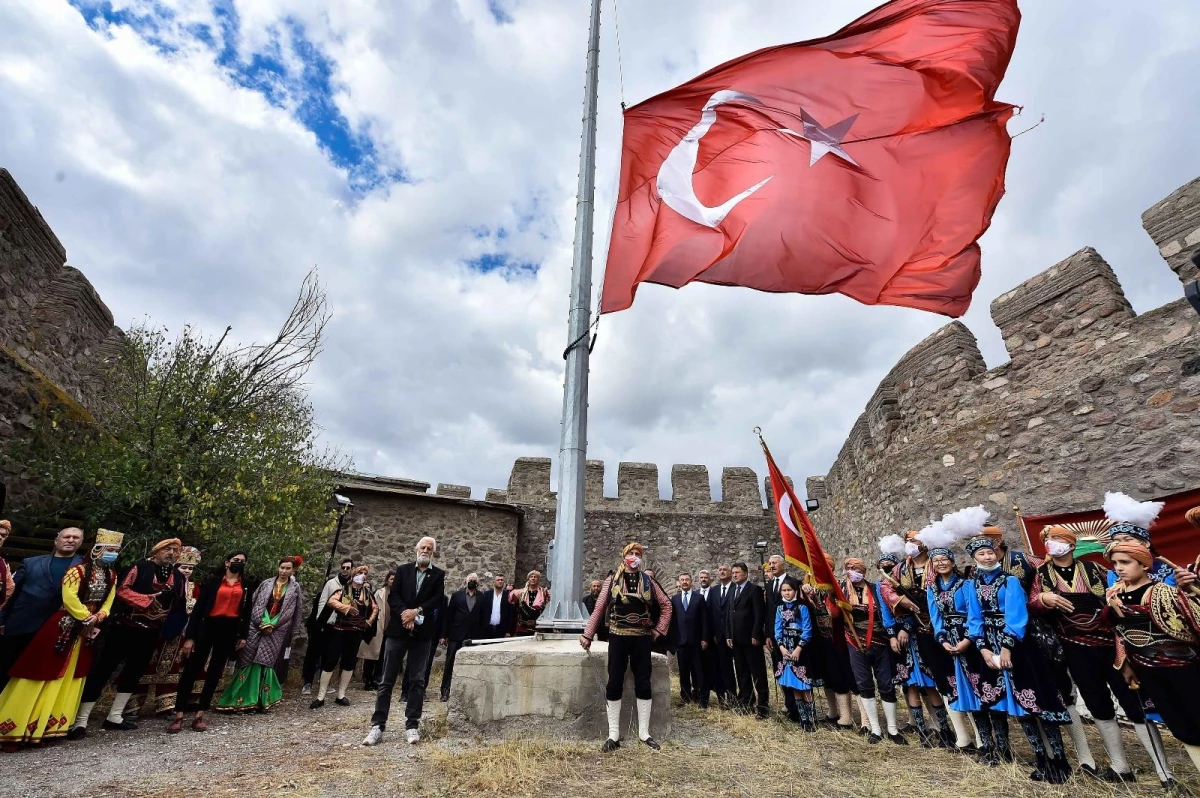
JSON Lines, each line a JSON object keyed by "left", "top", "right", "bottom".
{"left": 431, "top": 707, "right": 1200, "bottom": 798}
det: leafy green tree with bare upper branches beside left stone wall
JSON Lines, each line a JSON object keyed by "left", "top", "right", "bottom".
{"left": 11, "top": 271, "right": 349, "bottom": 576}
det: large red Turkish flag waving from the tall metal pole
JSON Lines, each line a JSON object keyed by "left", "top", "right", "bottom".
{"left": 600, "top": 0, "right": 1020, "bottom": 317}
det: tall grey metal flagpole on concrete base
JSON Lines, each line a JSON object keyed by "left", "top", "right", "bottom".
{"left": 538, "top": 0, "right": 600, "bottom": 631}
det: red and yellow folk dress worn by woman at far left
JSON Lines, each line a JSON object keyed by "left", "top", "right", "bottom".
{"left": 0, "top": 560, "right": 116, "bottom": 743}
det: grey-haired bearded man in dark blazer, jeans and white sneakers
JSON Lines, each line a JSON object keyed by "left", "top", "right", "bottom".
{"left": 362, "top": 538, "right": 446, "bottom": 745}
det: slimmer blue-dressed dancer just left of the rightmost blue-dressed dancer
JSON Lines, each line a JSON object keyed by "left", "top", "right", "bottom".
{"left": 926, "top": 546, "right": 991, "bottom": 757}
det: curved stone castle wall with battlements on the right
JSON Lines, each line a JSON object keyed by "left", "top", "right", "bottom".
{"left": 808, "top": 180, "right": 1200, "bottom": 557}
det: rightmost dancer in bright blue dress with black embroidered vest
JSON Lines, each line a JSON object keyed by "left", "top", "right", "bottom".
{"left": 967, "top": 535, "right": 1070, "bottom": 784}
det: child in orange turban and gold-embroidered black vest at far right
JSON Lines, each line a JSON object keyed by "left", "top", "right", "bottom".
{"left": 1105, "top": 541, "right": 1200, "bottom": 769}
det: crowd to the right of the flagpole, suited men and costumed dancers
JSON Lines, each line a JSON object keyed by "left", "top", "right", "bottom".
{"left": 580, "top": 494, "right": 1200, "bottom": 791}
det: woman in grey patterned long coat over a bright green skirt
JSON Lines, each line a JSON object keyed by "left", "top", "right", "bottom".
{"left": 216, "top": 557, "right": 304, "bottom": 712}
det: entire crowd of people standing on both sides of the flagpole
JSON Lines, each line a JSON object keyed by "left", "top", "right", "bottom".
{"left": 0, "top": 494, "right": 1200, "bottom": 790}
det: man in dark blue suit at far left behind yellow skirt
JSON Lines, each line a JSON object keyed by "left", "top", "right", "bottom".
{"left": 0, "top": 527, "right": 83, "bottom": 690}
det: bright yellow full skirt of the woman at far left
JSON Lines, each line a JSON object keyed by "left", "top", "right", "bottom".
{"left": 0, "top": 640, "right": 84, "bottom": 743}
